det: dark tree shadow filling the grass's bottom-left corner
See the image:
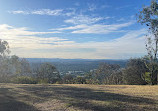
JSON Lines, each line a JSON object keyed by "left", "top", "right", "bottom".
{"left": 0, "top": 88, "right": 39, "bottom": 111}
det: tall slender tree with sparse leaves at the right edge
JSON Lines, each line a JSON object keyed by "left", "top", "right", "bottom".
{"left": 138, "top": 0, "right": 158, "bottom": 85}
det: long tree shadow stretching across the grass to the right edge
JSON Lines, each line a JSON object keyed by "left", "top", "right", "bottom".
{"left": 21, "top": 85, "right": 158, "bottom": 111}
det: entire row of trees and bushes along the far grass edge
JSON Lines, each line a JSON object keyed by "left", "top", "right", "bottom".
{"left": 0, "top": 40, "right": 158, "bottom": 85}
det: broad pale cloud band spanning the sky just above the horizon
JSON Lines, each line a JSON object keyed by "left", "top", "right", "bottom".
{"left": 0, "top": 24, "right": 145, "bottom": 59}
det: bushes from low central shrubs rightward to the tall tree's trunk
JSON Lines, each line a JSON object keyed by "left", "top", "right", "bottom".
{"left": 63, "top": 58, "right": 152, "bottom": 85}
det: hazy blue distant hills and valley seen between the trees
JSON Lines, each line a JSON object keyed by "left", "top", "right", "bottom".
{"left": 26, "top": 58, "right": 127, "bottom": 72}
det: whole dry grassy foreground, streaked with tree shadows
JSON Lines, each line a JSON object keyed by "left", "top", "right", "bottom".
{"left": 0, "top": 84, "right": 158, "bottom": 111}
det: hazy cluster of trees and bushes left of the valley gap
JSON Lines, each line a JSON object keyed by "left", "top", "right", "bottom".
{"left": 0, "top": 40, "right": 60, "bottom": 84}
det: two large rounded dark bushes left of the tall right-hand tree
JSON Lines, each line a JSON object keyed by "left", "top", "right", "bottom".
{"left": 84, "top": 59, "right": 148, "bottom": 85}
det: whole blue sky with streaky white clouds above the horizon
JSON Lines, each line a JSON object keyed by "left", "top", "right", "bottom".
{"left": 0, "top": 0, "right": 150, "bottom": 59}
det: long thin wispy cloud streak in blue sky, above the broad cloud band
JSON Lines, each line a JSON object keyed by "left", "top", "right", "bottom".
{"left": 52, "top": 21, "right": 135, "bottom": 34}
